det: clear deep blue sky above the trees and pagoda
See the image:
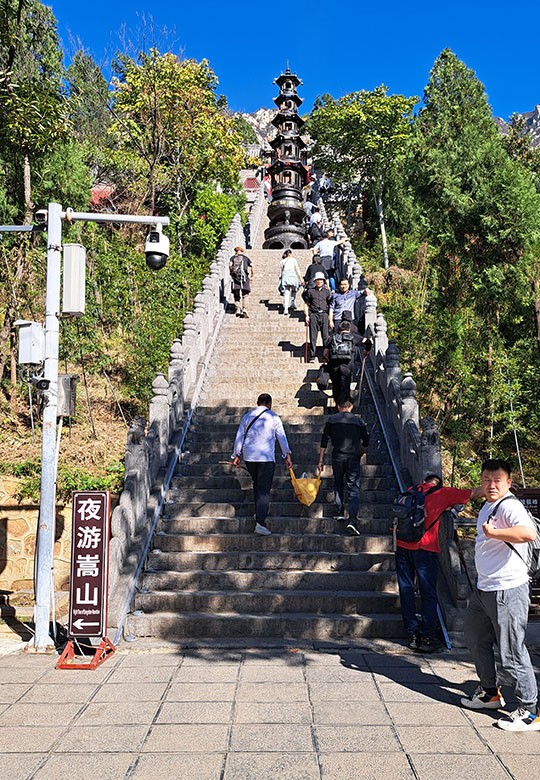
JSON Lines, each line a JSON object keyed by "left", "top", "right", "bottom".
{"left": 48, "top": 0, "right": 540, "bottom": 119}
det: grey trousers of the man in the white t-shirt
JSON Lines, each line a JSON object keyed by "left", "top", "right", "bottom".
{"left": 463, "top": 583, "right": 538, "bottom": 712}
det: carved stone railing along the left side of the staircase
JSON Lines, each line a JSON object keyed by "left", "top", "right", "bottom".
{"left": 109, "top": 214, "right": 243, "bottom": 628}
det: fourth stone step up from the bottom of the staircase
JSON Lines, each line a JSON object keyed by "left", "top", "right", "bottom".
{"left": 145, "top": 549, "right": 395, "bottom": 576}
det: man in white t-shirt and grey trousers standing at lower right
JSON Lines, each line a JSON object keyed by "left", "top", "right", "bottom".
{"left": 461, "top": 459, "right": 540, "bottom": 731}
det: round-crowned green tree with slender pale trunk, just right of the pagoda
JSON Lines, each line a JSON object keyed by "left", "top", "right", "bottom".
{"left": 309, "top": 85, "right": 417, "bottom": 268}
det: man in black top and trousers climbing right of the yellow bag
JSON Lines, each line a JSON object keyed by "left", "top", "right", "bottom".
{"left": 319, "top": 398, "right": 369, "bottom": 534}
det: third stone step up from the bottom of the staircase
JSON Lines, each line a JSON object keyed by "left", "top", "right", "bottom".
{"left": 139, "top": 569, "right": 397, "bottom": 593}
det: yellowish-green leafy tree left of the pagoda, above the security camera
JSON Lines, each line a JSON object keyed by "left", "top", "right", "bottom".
{"left": 111, "top": 49, "right": 243, "bottom": 217}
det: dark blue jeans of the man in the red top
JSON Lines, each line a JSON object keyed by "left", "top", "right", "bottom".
{"left": 396, "top": 547, "right": 438, "bottom": 639}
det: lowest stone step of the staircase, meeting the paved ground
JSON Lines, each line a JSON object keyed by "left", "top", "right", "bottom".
{"left": 127, "top": 612, "right": 403, "bottom": 641}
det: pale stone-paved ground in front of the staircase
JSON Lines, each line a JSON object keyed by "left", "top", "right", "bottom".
{"left": 0, "top": 639, "right": 540, "bottom": 780}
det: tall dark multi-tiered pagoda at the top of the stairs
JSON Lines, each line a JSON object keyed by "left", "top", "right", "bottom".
{"left": 263, "top": 68, "right": 308, "bottom": 249}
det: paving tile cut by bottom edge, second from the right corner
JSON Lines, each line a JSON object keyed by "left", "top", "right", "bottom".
{"left": 410, "top": 751, "right": 512, "bottom": 780}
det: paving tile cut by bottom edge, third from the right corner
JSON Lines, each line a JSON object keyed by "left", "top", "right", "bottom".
{"left": 319, "top": 753, "right": 414, "bottom": 780}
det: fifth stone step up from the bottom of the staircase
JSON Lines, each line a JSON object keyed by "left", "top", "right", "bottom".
{"left": 155, "top": 533, "right": 392, "bottom": 553}
